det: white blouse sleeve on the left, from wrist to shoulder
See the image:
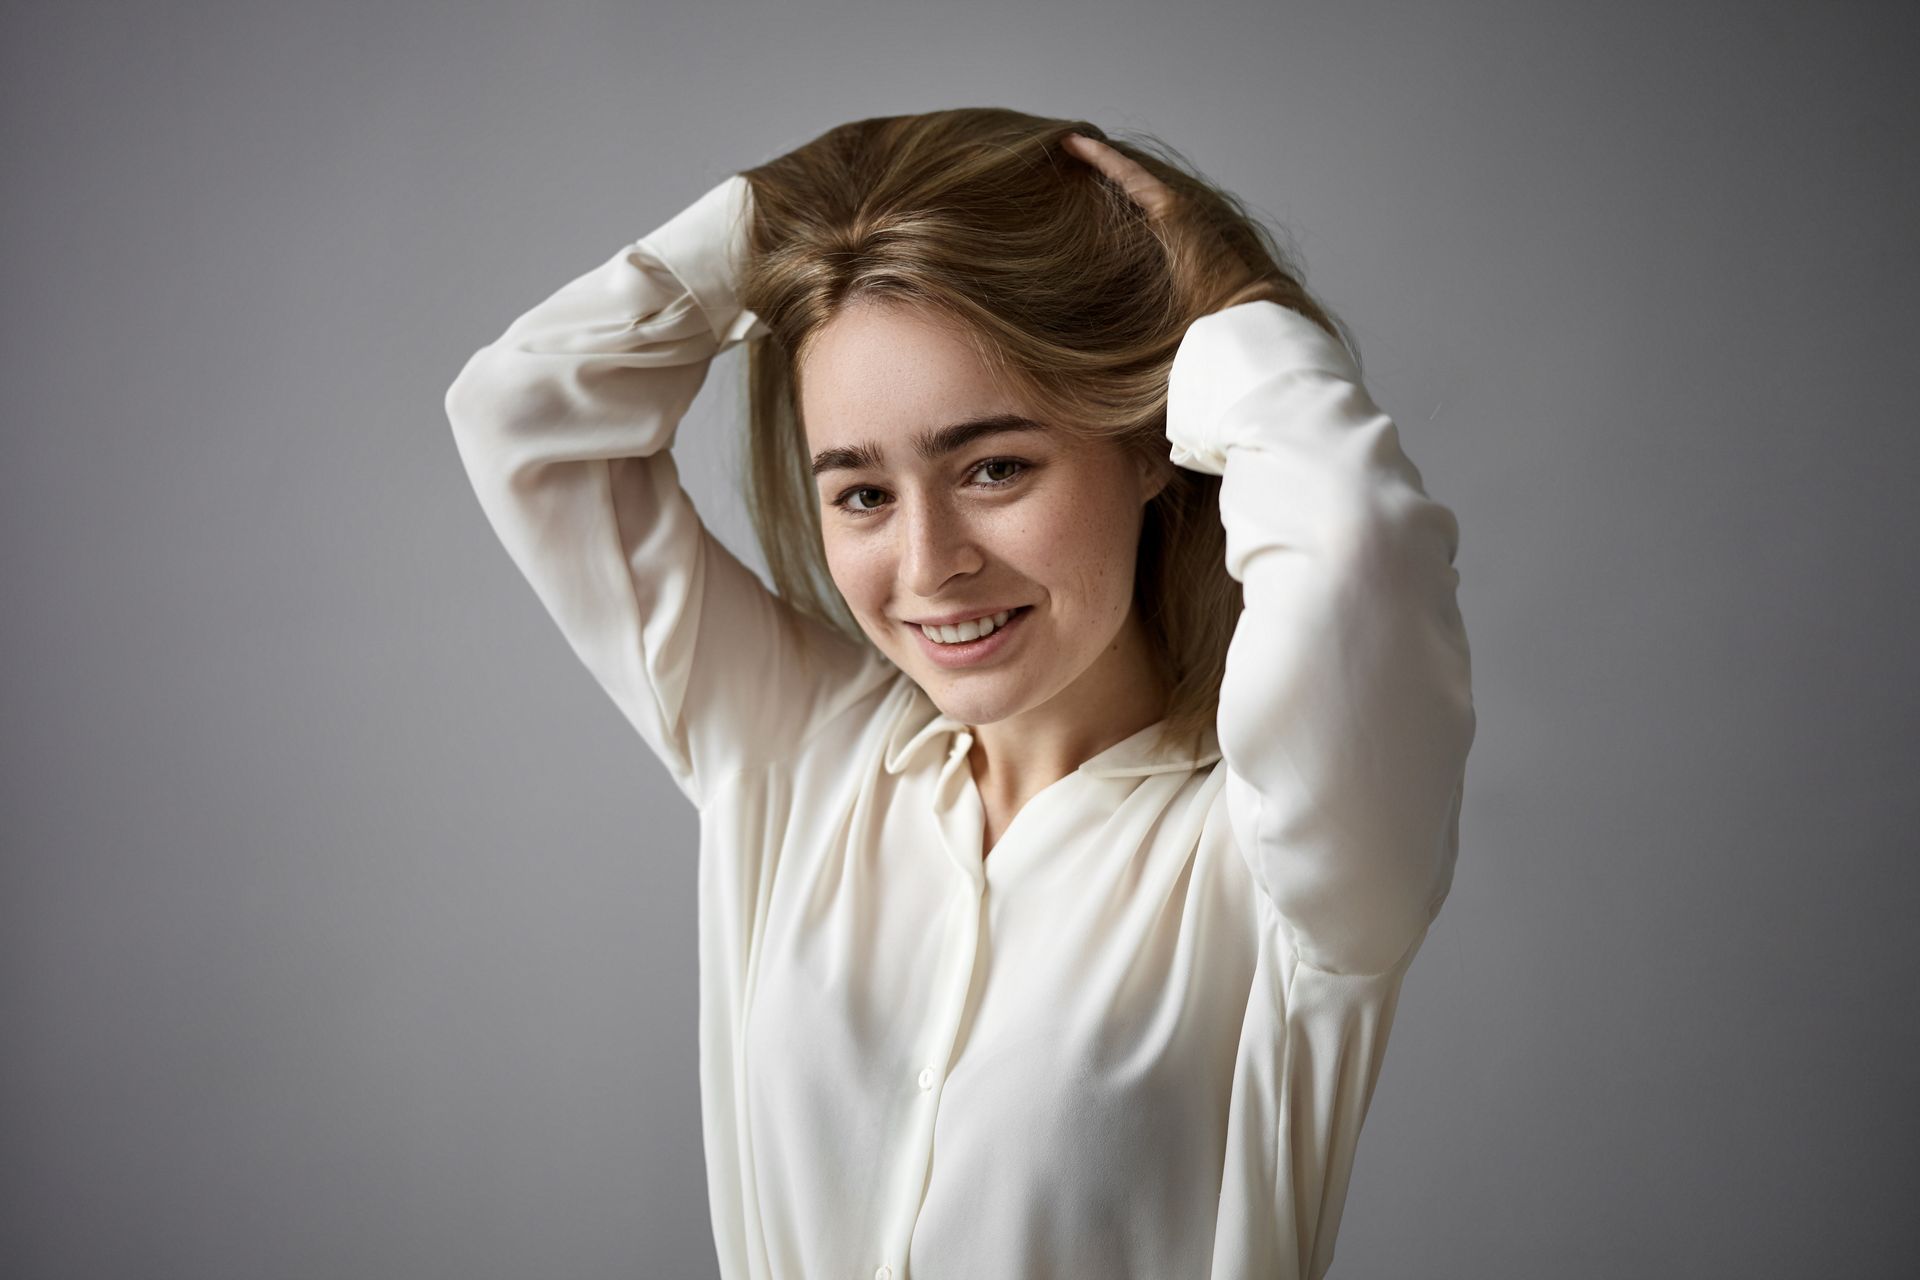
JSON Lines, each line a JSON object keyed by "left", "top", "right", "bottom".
{"left": 445, "top": 175, "right": 879, "bottom": 804}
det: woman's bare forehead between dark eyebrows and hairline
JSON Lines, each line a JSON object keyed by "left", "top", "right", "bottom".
{"left": 799, "top": 299, "right": 1020, "bottom": 449}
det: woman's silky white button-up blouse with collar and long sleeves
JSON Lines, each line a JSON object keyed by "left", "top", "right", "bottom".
{"left": 445, "top": 175, "right": 1475, "bottom": 1280}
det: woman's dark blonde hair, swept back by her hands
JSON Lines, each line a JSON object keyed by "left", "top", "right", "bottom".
{"left": 739, "top": 107, "right": 1357, "bottom": 759}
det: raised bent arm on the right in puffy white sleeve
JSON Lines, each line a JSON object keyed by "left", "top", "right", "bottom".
{"left": 1167, "top": 301, "right": 1475, "bottom": 975}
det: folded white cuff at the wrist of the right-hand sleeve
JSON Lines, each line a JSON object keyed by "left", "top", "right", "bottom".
{"left": 1167, "top": 299, "right": 1359, "bottom": 476}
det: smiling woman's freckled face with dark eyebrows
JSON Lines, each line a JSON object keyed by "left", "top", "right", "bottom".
{"left": 801, "top": 299, "right": 1164, "bottom": 725}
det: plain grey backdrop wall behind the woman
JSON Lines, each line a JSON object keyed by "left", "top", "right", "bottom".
{"left": 0, "top": 0, "right": 1920, "bottom": 1280}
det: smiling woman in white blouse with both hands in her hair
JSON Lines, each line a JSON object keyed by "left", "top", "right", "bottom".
{"left": 447, "top": 109, "right": 1475, "bottom": 1280}
